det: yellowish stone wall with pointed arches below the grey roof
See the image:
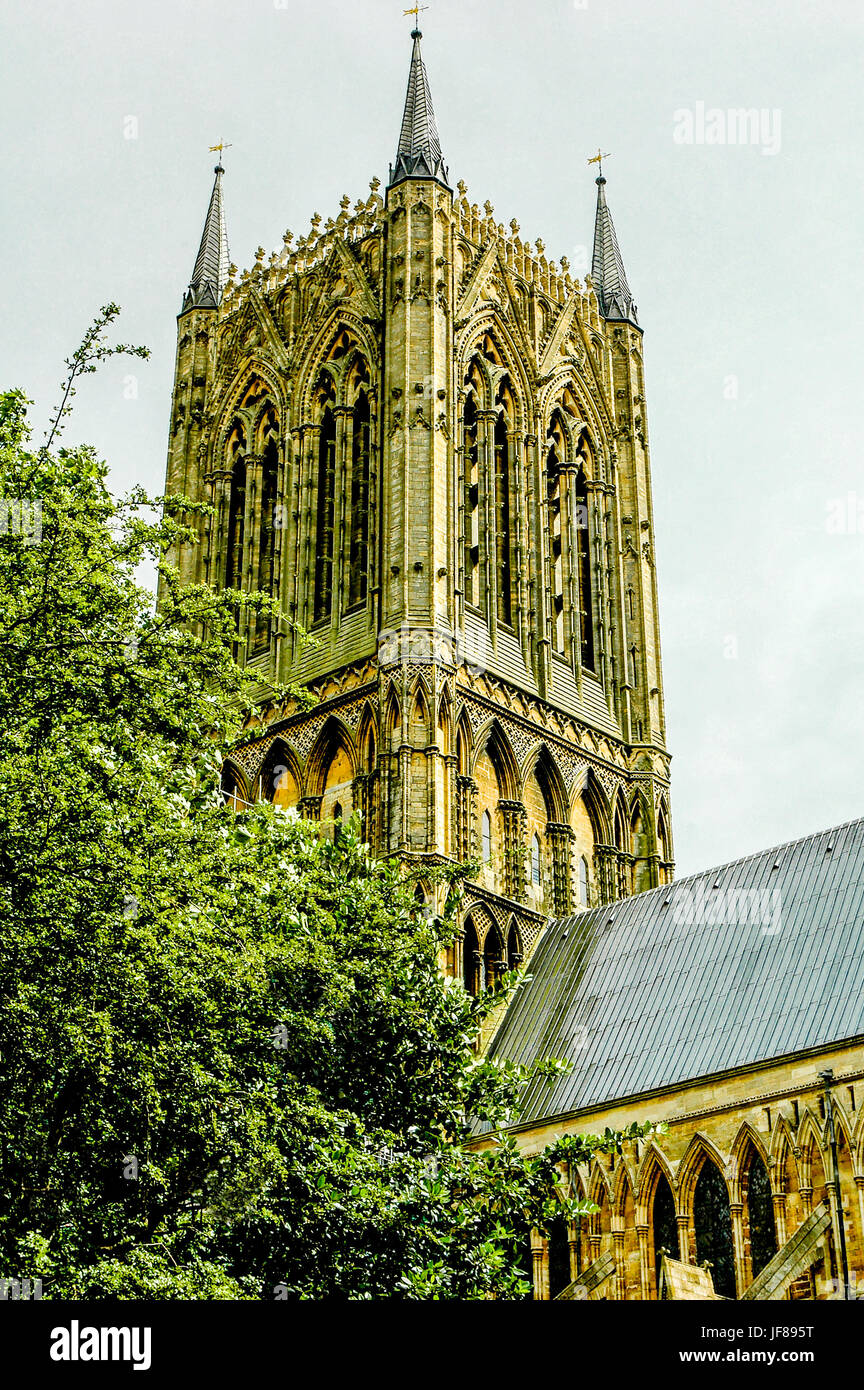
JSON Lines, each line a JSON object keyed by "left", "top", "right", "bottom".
{"left": 497, "top": 1043, "right": 864, "bottom": 1300}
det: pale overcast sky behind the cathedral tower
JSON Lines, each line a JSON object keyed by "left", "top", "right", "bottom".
{"left": 0, "top": 0, "right": 864, "bottom": 874}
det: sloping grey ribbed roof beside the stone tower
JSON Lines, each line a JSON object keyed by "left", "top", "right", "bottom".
{"left": 490, "top": 820, "right": 864, "bottom": 1125}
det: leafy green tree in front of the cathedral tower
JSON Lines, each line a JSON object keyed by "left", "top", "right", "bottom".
{"left": 0, "top": 306, "right": 663, "bottom": 1298}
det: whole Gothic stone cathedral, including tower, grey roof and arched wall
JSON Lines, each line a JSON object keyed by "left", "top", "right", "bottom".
{"left": 165, "top": 29, "right": 864, "bottom": 1300}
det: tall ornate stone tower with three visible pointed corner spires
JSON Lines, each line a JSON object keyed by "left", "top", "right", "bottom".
{"left": 167, "top": 31, "right": 672, "bottom": 990}
